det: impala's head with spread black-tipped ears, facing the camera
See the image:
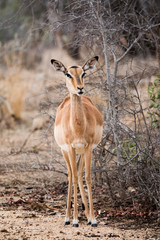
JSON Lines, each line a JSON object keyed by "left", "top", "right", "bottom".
{"left": 51, "top": 56, "right": 98, "bottom": 96}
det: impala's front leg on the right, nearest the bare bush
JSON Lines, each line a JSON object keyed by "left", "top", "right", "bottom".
{"left": 85, "top": 146, "right": 97, "bottom": 227}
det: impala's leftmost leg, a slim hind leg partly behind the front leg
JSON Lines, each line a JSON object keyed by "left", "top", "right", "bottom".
{"left": 62, "top": 150, "right": 72, "bottom": 225}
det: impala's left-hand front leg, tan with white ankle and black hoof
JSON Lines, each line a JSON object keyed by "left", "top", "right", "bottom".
{"left": 68, "top": 147, "right": 78, "bottom": 227}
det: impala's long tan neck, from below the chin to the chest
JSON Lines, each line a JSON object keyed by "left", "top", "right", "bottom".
{"left": 71, "top": 94, "right": 85, "bottom": 136}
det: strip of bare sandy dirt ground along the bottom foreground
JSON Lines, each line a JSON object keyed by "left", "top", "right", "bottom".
{"left": 0, "top": 210, "right": 160, "bottom": 240}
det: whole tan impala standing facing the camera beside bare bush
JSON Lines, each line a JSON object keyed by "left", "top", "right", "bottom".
{"left": 51, "top": 56, "right": 103, "bottom": 227}
